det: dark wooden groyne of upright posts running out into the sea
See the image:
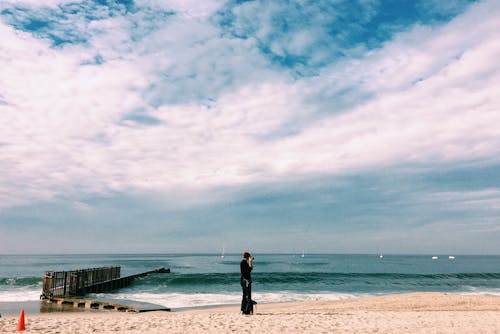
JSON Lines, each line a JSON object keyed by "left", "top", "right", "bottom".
{"left": 40, "top": 266, "right": 170, "bottom": 299}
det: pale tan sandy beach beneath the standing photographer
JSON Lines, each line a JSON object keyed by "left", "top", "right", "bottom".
{"left": 0, "top": 293, "right": 500, "bottom": 334}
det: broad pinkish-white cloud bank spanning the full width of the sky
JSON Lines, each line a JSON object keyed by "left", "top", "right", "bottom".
{"left": 0, "top": 2, "right": 500, "bottom": 206}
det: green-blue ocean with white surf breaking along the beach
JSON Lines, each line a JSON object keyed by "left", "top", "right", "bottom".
{"left": 0, "top": 254, "right": 500, "bottom": 313}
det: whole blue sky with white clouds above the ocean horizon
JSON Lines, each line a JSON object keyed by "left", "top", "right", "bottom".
{"left": 0, "top": 0, "right": 500, "bottom": 254}
